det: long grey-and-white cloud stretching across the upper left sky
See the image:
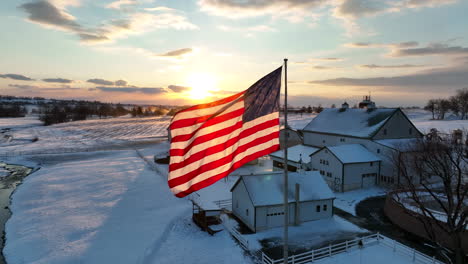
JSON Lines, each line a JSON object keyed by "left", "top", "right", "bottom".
{"left": 18, "top": 0, "right": 198, "bottom": 44}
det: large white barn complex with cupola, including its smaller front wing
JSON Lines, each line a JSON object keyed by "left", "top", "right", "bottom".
{"left": 270, "top": 96, "right": 423, "bottom": 191}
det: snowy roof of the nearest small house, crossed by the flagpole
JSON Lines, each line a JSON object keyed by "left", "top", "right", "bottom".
{"left": 231, "top": 171, "right": 335, "bottom": 206}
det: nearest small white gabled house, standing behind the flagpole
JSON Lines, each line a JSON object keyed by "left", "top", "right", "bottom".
{"left": 231, "top": 171, "right": 335, "bottom": 232}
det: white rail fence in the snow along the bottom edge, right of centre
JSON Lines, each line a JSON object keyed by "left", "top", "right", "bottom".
{"left": 262, "top": 233, "right": 443, "bottom": 264}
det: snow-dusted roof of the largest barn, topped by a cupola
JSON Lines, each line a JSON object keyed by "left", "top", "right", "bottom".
{"left": 304, "top": 108, "right": 400, "bottom": 138}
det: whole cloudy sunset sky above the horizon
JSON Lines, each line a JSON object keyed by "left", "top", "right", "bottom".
{"left": 0, "top": 0, "right": 468, "bottom": 107}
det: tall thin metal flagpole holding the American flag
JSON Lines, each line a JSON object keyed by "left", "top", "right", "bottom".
{"left": 283, "top": 59, "right": 289, "bottom": 264}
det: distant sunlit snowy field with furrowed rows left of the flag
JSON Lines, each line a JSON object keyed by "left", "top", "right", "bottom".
{"left": 0, "top": 117, "right": 170, "bottom": 156}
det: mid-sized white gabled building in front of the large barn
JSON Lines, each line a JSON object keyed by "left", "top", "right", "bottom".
{"left": 311, "top": 144, "right": 382, "bottom": 192}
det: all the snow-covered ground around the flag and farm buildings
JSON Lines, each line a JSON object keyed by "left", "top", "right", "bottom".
{"left": 0, "top": 108, "right": 468, "bottom": 263}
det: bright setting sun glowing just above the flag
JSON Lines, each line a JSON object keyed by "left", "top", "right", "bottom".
{"left": 187, "top": 73, "right": 216, "bottom": 100}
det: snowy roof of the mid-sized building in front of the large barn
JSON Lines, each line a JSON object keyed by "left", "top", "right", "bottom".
{"left": 324, "top": 144, "right": 381, "bottom": 164}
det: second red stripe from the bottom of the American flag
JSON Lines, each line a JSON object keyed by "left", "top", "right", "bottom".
{"left": 168, "top": 131, "right": 279, "bottom": 188}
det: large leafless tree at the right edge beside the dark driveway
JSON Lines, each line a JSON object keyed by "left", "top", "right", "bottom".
{"left": 394, "top": 140, "right": 468, "bottom": 264}
